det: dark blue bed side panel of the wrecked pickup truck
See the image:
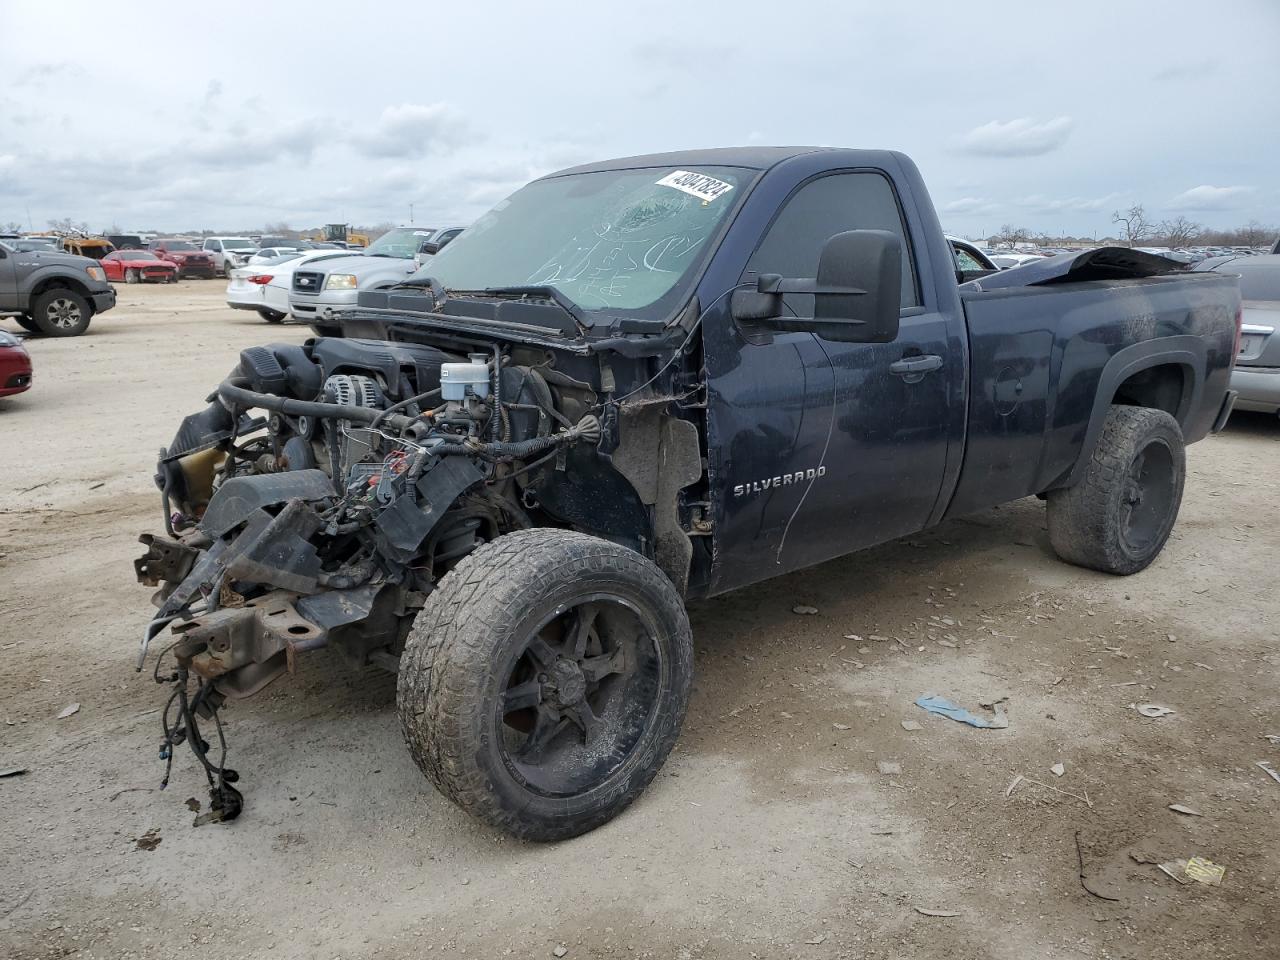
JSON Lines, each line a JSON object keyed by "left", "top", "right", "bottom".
{"left": 947, "top": 274, "right": 1239, "bottom": 516}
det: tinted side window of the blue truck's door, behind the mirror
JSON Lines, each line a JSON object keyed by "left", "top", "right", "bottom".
{"left": 746, "top": 173, "right": 920, "bottom": 308}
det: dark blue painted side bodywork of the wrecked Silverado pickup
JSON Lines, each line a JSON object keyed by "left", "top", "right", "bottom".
{"left": 673, "top": 150, "right": 1239, "bottom": 594}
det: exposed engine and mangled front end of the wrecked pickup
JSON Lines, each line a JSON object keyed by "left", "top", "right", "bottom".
{"left": 136, "top": 338, "right": 616, "bottom": 820}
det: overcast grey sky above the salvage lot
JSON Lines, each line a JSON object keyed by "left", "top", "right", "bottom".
{"left": 0, "top": 0, "right": 1280, "bottom": 237}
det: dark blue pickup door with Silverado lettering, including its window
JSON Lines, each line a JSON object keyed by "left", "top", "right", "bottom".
{"left": 707, "top": 170, "right": 963, "bottom": 593}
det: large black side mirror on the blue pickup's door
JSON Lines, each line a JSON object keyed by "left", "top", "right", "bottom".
{"left": 731, "top": 230, "right": 902, "bottom": 343}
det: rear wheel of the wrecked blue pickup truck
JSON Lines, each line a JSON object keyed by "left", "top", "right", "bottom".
{"left": 1048, "top": 407, "right": 1187, "bottom": 575}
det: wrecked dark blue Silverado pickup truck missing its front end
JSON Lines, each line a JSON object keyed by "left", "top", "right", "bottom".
{"left": 137, "top": 147, "right": 1239, "bottom": 840}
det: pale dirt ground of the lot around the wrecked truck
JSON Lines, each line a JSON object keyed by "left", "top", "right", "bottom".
{"left": 0, "top": 280, "right": 1280, "bottom": 960}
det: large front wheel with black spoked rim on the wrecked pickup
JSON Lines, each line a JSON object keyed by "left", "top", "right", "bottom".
{"left": 397, "top": 529, "right": 692, "bottom": 840}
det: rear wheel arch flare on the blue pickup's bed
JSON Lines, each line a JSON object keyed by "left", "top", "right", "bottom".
{"left": 1062, "top": 335, "right": 1208, "bottom": 486}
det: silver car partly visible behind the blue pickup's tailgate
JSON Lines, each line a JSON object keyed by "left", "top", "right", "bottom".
{"left": 1192, "top": 253, "right": 1280, "bottom": 413}
